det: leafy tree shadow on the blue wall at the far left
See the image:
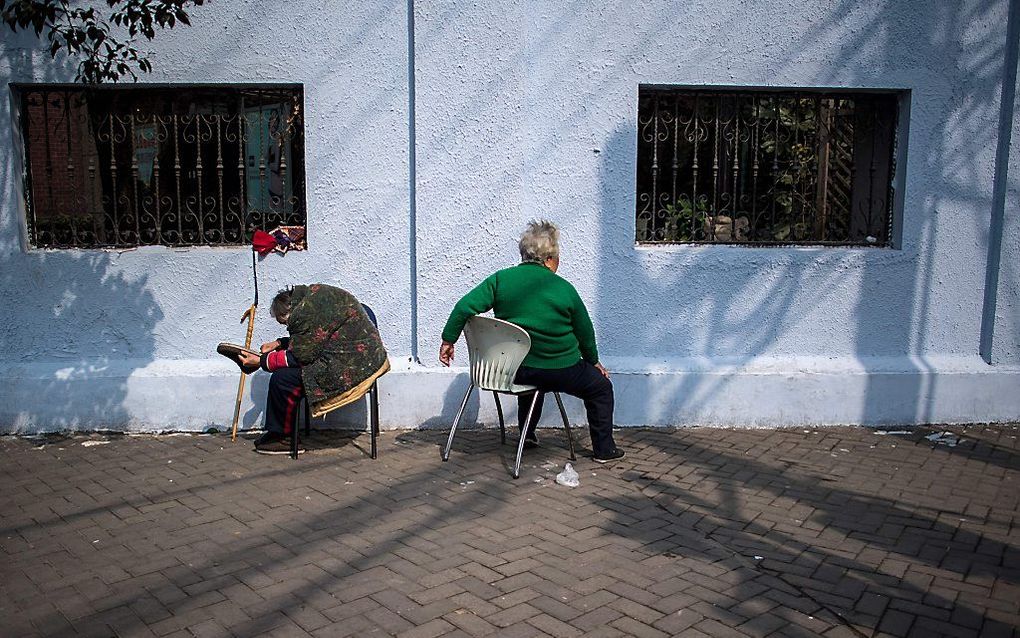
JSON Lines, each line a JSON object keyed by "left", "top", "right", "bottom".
{"left": 0, "top": 39, "right": 162, "bottom": 432}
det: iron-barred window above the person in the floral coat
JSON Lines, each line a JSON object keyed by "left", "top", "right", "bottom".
{"left": 13, "top": 85, "right": 305, "bottom": 248}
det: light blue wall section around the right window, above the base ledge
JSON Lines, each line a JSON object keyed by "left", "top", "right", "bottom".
{"left": 416, "top": 2, "right": 1006, "bottom": 358}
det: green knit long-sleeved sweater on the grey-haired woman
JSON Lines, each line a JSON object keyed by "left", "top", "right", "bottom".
{"left": 443, "top": 263, "right": 599, "bottom": 369}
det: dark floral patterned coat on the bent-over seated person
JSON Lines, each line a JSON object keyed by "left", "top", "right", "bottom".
{"left": 287, "top": 284, "right": 390, "bottom": 416}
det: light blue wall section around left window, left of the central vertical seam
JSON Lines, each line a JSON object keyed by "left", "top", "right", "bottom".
{"left": 0, "top": 2, "right": 410, "bottom": 423}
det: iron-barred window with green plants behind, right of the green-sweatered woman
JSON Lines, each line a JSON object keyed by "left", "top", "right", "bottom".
{"left": 636, "top": 86, "right": 899, "bottom": 246}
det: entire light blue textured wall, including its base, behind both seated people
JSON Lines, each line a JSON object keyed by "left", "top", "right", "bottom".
{"left": 0, "top": 0, "right": 1020, "bottom": 429}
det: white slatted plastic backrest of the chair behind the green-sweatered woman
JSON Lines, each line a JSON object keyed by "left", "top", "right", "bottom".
{"left": 464, "top": 316, "right": 531, "bottom": 392}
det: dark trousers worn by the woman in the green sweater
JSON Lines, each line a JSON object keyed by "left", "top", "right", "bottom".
{"left": 514, "top": 359, "right": 616, "bottom": 455}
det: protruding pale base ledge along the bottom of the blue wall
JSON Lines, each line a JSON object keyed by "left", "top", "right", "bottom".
{"left": 0, "top": 354, "right": 1020, "bottom": 433}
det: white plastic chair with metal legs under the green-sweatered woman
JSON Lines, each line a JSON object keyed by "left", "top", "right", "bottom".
{"left": 443, "top": 316, "right": 577, "bottom": 479}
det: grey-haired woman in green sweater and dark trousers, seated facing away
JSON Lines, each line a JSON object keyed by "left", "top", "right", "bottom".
{"left": 440, "top": 220, "right": 623, "bottom": 463}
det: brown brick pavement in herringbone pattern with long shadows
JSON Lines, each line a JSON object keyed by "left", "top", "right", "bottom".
{"left": 0, "top": 426, "right": 1020, "bottom": 637}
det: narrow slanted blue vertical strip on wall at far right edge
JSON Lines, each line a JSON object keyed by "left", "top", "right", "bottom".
{"left": 979, "top": 0, "right": 1020, "bottom": 363}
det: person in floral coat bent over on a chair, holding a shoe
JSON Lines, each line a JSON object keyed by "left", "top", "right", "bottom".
{"left": 241, "top": 284, "right": 390, "bottom": 454}
